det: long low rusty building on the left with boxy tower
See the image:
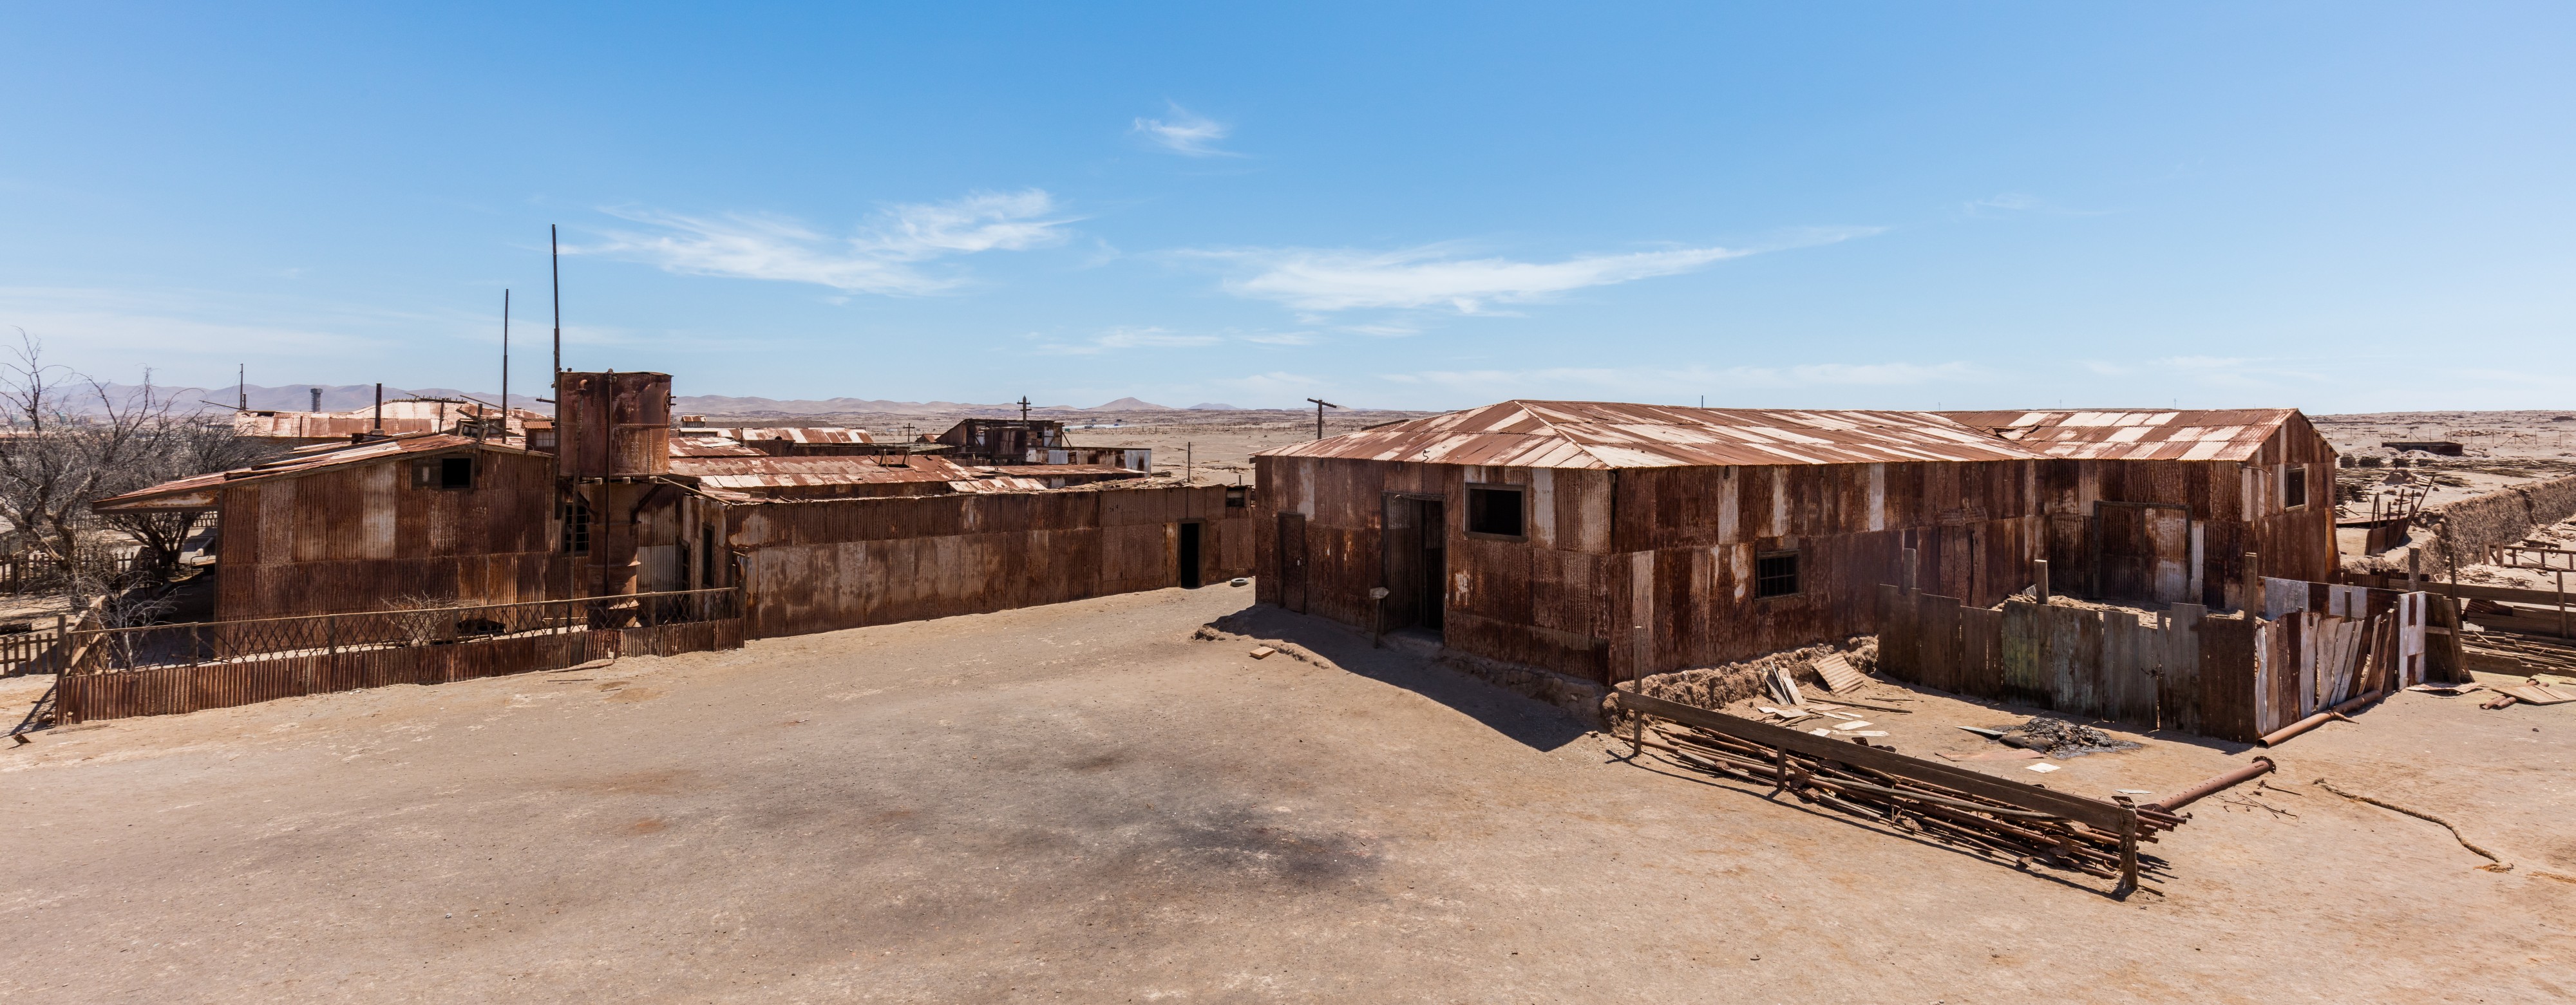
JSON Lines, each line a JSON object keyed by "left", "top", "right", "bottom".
{"left": 98, "top": 371, "right": 1252, "bottom": 634}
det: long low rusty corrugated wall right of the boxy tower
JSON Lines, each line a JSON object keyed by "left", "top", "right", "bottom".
{"left": 726, "top": 484, "right": 1252, "bottom": 637}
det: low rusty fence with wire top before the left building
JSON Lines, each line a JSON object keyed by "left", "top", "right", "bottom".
{"left": 57, "top": 588, "right": 742, "bottom": 722}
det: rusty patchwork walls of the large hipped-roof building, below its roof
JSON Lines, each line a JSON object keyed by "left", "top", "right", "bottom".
{"left": 1255, "top": 456, "right": 2040, "bottom": 681}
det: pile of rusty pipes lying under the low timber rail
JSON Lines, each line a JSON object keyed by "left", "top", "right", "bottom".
{"left": 1633, "top": 722, "right": 2184, "bottom": 879}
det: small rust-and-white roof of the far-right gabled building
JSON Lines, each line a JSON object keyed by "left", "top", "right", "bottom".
{"left": 1942, "top": 407, "right": 2298, "bottom": 461}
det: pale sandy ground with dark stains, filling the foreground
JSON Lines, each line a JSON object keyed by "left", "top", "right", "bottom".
{"left": 0, "top": 585, "right": 2576, "bottom": 1002}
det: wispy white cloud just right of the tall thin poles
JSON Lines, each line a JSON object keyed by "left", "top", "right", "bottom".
{"left": 580, "top": 188, "right": 1072, "bottom": 296}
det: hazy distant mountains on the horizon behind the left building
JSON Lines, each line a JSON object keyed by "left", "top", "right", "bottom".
{"left": 64, "top": 384, "right": 1236, "bottom": 415}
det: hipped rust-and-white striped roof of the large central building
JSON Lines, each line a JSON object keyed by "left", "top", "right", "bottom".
{"left": 1257, "top": 402, "right": 2035, "bottom": 469}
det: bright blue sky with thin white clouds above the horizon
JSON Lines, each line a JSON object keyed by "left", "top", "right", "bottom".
{"left": 0, "top": 3, "right": 2576, "bottom": 412}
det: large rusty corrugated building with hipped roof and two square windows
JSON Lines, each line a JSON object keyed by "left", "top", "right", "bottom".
{"left": 1255, "top": 402, "right": 2043, "bottom": 683}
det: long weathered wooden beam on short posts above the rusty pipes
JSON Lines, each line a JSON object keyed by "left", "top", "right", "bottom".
{"left": 1613, "top": 688, "right": 2161, "bottom": 894}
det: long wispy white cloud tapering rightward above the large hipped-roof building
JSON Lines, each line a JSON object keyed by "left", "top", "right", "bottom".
{"left": 1185, "top": 229, "right": 1878, "bottom": 314}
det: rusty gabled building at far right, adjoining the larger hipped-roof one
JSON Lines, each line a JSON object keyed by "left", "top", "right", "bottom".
{"left": 1942, "top": 407, "right": 2339, "bottom": 608}
